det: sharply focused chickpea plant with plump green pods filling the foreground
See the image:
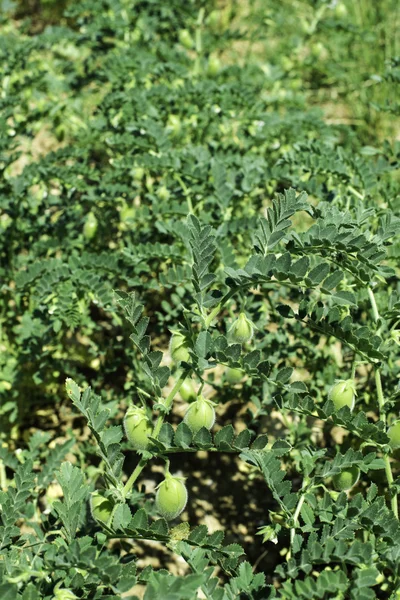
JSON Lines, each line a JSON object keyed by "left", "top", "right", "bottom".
{"left": 0, "top": 189, "right": 400, "bottom": 600}
